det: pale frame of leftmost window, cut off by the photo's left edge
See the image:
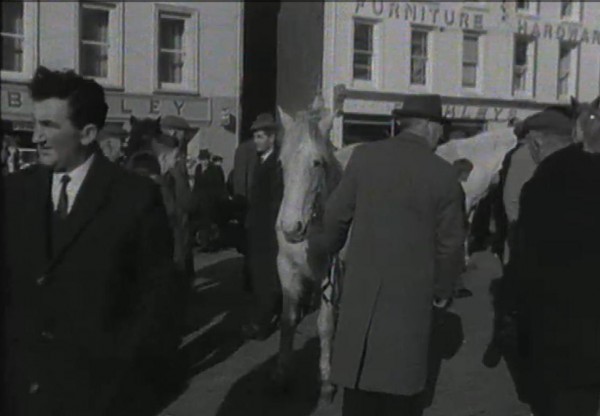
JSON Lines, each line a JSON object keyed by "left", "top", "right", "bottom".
{"left": 0, "top": 1, "right": 39, "bottom": 82}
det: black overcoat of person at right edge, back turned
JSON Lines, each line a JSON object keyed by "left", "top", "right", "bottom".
{"left": 516, "top": 111, "right": 600, "bottom": 416}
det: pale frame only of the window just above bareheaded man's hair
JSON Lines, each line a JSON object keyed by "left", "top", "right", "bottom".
{"left": 75, "top": 0, "right": 125, "bottom": 89}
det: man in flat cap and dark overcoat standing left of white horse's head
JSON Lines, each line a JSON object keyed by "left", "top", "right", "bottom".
{"left": 243, "top": 113, "right": 283, "bottom": 339}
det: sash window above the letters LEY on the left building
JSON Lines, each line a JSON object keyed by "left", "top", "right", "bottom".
{"left": 157, "top": 8, "right": 198, "bottom": 91}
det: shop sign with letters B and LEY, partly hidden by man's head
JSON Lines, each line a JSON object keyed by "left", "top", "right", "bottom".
{"left": 1, "top": 85, "right": 211, "bottom": 124}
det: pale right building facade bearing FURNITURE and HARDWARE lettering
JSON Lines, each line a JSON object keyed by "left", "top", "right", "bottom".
{"left": 278, "top": 0, "right": 600, "bottom": 146}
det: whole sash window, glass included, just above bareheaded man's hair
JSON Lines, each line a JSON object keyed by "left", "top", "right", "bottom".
{"left": 79, "top": 2, "right": 123, "bottom": 86}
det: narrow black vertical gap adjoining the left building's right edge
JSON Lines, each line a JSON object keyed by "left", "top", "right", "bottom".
{"left": 240, "top": 1, "right": 280, "bottom": 145}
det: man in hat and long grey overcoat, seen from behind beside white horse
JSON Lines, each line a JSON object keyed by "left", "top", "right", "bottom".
{"left": 310, "top": 95, "right": 465, "bottom": 416}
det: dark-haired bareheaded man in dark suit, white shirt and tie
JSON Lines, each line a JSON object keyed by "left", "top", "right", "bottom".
{"left": 2, "top": 67, "right": 174, "bottom": 416}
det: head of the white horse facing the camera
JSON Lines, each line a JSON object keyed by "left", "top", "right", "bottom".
{"left": 278, "top": 101, "right": 341, "bottom": 243}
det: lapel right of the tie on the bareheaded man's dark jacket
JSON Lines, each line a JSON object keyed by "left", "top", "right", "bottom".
{"left": 48, "top": 153, "right": 114, "bottom": 271}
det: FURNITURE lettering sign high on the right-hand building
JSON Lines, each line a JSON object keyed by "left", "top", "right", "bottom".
{"left": 354, "top": 0, "right": 485, "bottom": 30}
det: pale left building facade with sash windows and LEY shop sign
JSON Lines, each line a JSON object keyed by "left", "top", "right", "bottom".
{"left": 1, "top": 1, "right": 243, "bottom": 169}
